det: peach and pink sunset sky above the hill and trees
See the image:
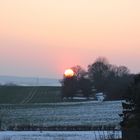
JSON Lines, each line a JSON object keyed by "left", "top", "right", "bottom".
{"left": 0, "top": 0, "right": 140, "bottom": 78}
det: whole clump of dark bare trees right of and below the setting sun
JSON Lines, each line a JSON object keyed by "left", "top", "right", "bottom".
{"left": 61, "top": 57, "right": 134, "bottom": 100}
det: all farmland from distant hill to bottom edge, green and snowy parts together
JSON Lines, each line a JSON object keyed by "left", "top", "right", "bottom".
{"left": 0, "top": 86, "right": 122, "bottom": 140}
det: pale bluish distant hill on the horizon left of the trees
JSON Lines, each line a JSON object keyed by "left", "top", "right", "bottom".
{"left": 0, "top": 76, "right": 61, "bottom": 86}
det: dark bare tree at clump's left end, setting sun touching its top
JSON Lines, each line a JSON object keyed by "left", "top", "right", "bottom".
{"left": 61, "top": 65, "right": 92, "bottom": 99}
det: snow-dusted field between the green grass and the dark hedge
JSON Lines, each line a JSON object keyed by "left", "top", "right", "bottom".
{"left": 1, "top": 101, "right": 122, "bottom": 130}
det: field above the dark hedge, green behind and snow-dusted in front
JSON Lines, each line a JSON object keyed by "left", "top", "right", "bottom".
{"left": 0, "top": 86, "right": 122, "bottom": 129}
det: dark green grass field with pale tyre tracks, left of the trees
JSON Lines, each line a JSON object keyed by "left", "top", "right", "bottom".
{"left": 0, "top": 86, "right": 61, "bottom": 104}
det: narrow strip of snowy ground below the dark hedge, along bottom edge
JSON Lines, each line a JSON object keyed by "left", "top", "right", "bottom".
{"left": 0, "top": 131, "right": 122, "bottom": 140}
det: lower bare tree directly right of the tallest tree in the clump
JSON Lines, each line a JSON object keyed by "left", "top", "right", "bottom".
{"left": 107, "top": 65, "right": 132, "bottom": 99}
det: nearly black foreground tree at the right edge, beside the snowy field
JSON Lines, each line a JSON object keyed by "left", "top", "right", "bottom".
{"left": 121, "top": 74, "right": 140, "bottom": 140}
